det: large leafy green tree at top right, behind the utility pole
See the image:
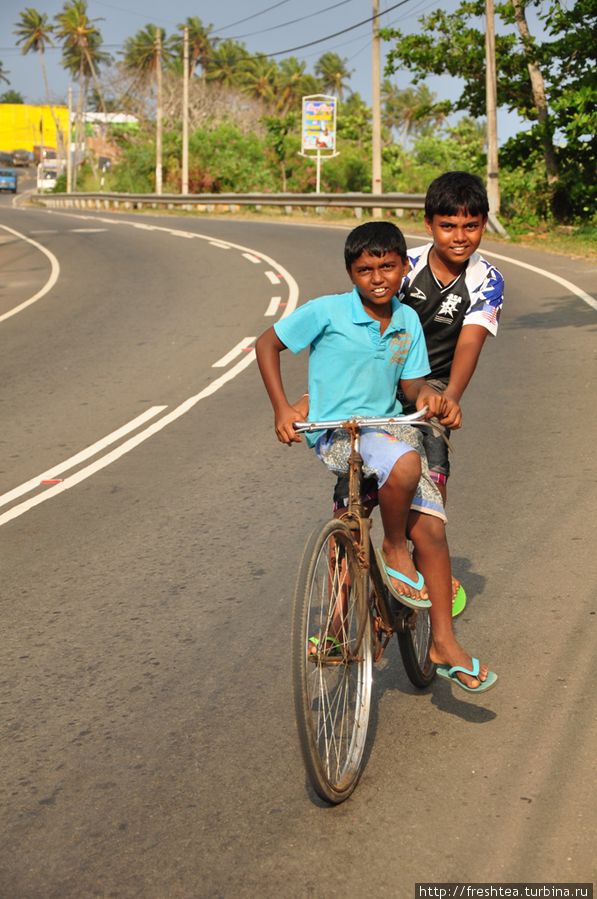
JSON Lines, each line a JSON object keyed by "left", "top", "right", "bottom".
{"left": 382, "top": 0, "right": 596, "bottom": 217}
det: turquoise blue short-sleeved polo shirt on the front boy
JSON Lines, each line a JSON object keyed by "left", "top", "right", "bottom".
{"left": 274, "top": 287, "right": 430, "bottom": 446}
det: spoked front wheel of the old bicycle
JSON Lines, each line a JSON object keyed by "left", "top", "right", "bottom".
{"left": 292, "top": 519, "right": 373, "bottom": 804}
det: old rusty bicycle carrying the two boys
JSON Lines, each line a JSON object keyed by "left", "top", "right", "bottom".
{"left": 291, "top": 409, "right": 435, "bottom": 804}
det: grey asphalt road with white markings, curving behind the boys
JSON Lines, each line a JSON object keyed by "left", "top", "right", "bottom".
{"left": 0, "top": 198, "right": 597, "bottom": 899}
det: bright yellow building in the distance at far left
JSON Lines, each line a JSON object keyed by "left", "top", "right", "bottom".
{"left": 0, "top": 103, "right": 68, "bottom": 152}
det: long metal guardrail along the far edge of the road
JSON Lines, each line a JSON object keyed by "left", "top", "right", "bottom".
{"left": 30, "top": 192, "right": 506, "bottom": 236}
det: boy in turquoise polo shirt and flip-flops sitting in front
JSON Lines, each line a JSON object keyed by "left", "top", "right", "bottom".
{"left": 256, "top": 222, "right": 497, "bottom": 692}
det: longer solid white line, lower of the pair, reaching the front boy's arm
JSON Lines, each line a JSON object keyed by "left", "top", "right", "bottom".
{"left": 0, "top": 350, "right": 255, "bottom": 526}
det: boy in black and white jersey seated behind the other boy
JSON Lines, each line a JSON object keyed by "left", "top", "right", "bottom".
{"left": 326, "top": 172, "right": 504, "bottom": 614}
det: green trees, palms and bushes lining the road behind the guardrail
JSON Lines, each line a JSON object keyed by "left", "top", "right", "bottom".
{"left": 0, "top": 0, "right": 597, "bottom": 249}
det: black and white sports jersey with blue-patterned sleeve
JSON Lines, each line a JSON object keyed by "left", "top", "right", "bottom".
{"left": 400, "top": 244, "right": 504, "bottom": 381}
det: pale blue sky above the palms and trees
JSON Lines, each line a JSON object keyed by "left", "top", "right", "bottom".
{"left": 0, "top": 0, "right": 532, "bottom": 144}
